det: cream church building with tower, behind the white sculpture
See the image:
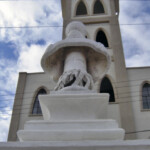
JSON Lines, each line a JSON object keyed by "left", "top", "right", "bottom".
{"left": 8, "top": 0, "right": 150, "bottom": 141}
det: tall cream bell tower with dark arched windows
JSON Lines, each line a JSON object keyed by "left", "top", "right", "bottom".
{"left": 61, "top": 0, "right": 135, "bottom": 139}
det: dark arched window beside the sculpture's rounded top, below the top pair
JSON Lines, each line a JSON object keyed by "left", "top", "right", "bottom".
{"left": 96, "top": 30, "right": 109, "bottom": 47}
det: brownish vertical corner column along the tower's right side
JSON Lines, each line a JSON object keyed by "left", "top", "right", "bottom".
{"left": 110, "top": 16, "right": 135, "bottom": 139}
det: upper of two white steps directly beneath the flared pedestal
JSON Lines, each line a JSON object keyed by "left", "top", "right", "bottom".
{"left": 24, "top": 119, "right": 118, "bottom": 130}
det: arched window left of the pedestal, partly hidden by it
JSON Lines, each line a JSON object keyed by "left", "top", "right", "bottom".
{"left": 32, "top": 89, "right": 47, "bottom": 115}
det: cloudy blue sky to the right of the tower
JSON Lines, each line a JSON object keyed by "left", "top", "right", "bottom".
{"left": 120, "top": 1, "right": 150, "bottom": 67}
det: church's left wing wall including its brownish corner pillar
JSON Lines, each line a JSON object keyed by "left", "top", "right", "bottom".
{"left": 8, "top": 73, "right": 55, "bottom": 141}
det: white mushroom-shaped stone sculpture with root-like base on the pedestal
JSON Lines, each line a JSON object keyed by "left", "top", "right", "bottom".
{"left": 41, "top": 22, "right": 110, "bottom": 92}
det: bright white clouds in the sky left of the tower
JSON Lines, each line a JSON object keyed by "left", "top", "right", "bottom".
{"left": 0, "top": 0, "right": 62, "bottom": 141}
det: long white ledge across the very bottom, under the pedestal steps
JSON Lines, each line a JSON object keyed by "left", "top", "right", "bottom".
{"left": 0, "top": 140, "right": 150, "bottom": 150}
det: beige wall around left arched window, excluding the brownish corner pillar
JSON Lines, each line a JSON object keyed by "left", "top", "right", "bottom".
{"left": 19, "top": 73, "right": 55, "bottom": 129}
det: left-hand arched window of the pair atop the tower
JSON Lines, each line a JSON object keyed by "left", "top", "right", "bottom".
{"left": 76, "top": 1, "right": 87, "bottom": 16}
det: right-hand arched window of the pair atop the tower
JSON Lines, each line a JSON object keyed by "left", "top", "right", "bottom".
{"left": 93, "top": 0, "right": 104, "bottom": 14}
